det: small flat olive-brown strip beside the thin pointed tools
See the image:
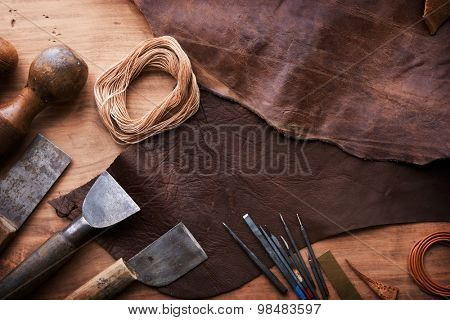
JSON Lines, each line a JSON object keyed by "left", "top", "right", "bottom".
{"left": 317, "top": 250, "right": 362, "bottom": 300}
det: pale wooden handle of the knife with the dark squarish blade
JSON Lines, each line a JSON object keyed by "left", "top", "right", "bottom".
{"left": 66, "top": 259, "right": 136, "bottom": 300}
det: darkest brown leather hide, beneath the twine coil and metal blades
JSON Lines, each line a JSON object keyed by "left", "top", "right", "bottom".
{"left": 52, "top": 90, "right": 450, "bottom": 298}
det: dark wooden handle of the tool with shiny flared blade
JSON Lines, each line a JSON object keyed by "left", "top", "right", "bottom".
{"left": 0, "top": 233, "right": 76, "bottom": 299}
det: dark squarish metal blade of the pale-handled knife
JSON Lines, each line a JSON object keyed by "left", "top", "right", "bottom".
{"left": 128, "top": 223, "right": 208, "bottom": 287}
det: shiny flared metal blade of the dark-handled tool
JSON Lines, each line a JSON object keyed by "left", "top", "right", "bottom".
{"left": 83, "top": 171, "right": 141, "bottom": 228}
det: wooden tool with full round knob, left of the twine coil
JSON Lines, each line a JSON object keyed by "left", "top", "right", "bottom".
{"left": 0, "top": 46, "right": 88, "bottom": 157}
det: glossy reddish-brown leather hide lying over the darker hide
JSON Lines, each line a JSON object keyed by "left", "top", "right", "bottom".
{"left": 135, "top": 0, "right": 450, "bottom": 164}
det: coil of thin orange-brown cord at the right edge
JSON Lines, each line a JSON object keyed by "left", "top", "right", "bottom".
{"left": 408, "top": 231, "right": 450, "bottom": 298}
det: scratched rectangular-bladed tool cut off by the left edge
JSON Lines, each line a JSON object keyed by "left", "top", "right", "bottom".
{"left": 0, "top": 134, "right": 70, "bottom": 251}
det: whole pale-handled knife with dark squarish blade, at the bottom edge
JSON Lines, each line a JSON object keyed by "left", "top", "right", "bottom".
{"left": 66, "top": 223, "right": 208, "bottom": 300}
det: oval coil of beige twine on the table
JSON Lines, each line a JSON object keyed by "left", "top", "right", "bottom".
{"left": 94, "top": 36, "right": 200, "bottom": 144}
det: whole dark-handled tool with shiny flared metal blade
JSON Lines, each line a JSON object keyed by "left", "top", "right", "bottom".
{"left": 0, "top": 172, "right": 140, "bottom": 299}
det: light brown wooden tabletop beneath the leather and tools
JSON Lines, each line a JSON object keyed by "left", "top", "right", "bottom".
{"left": 0, "top": 0, "right": 450, "bottom": 299}
